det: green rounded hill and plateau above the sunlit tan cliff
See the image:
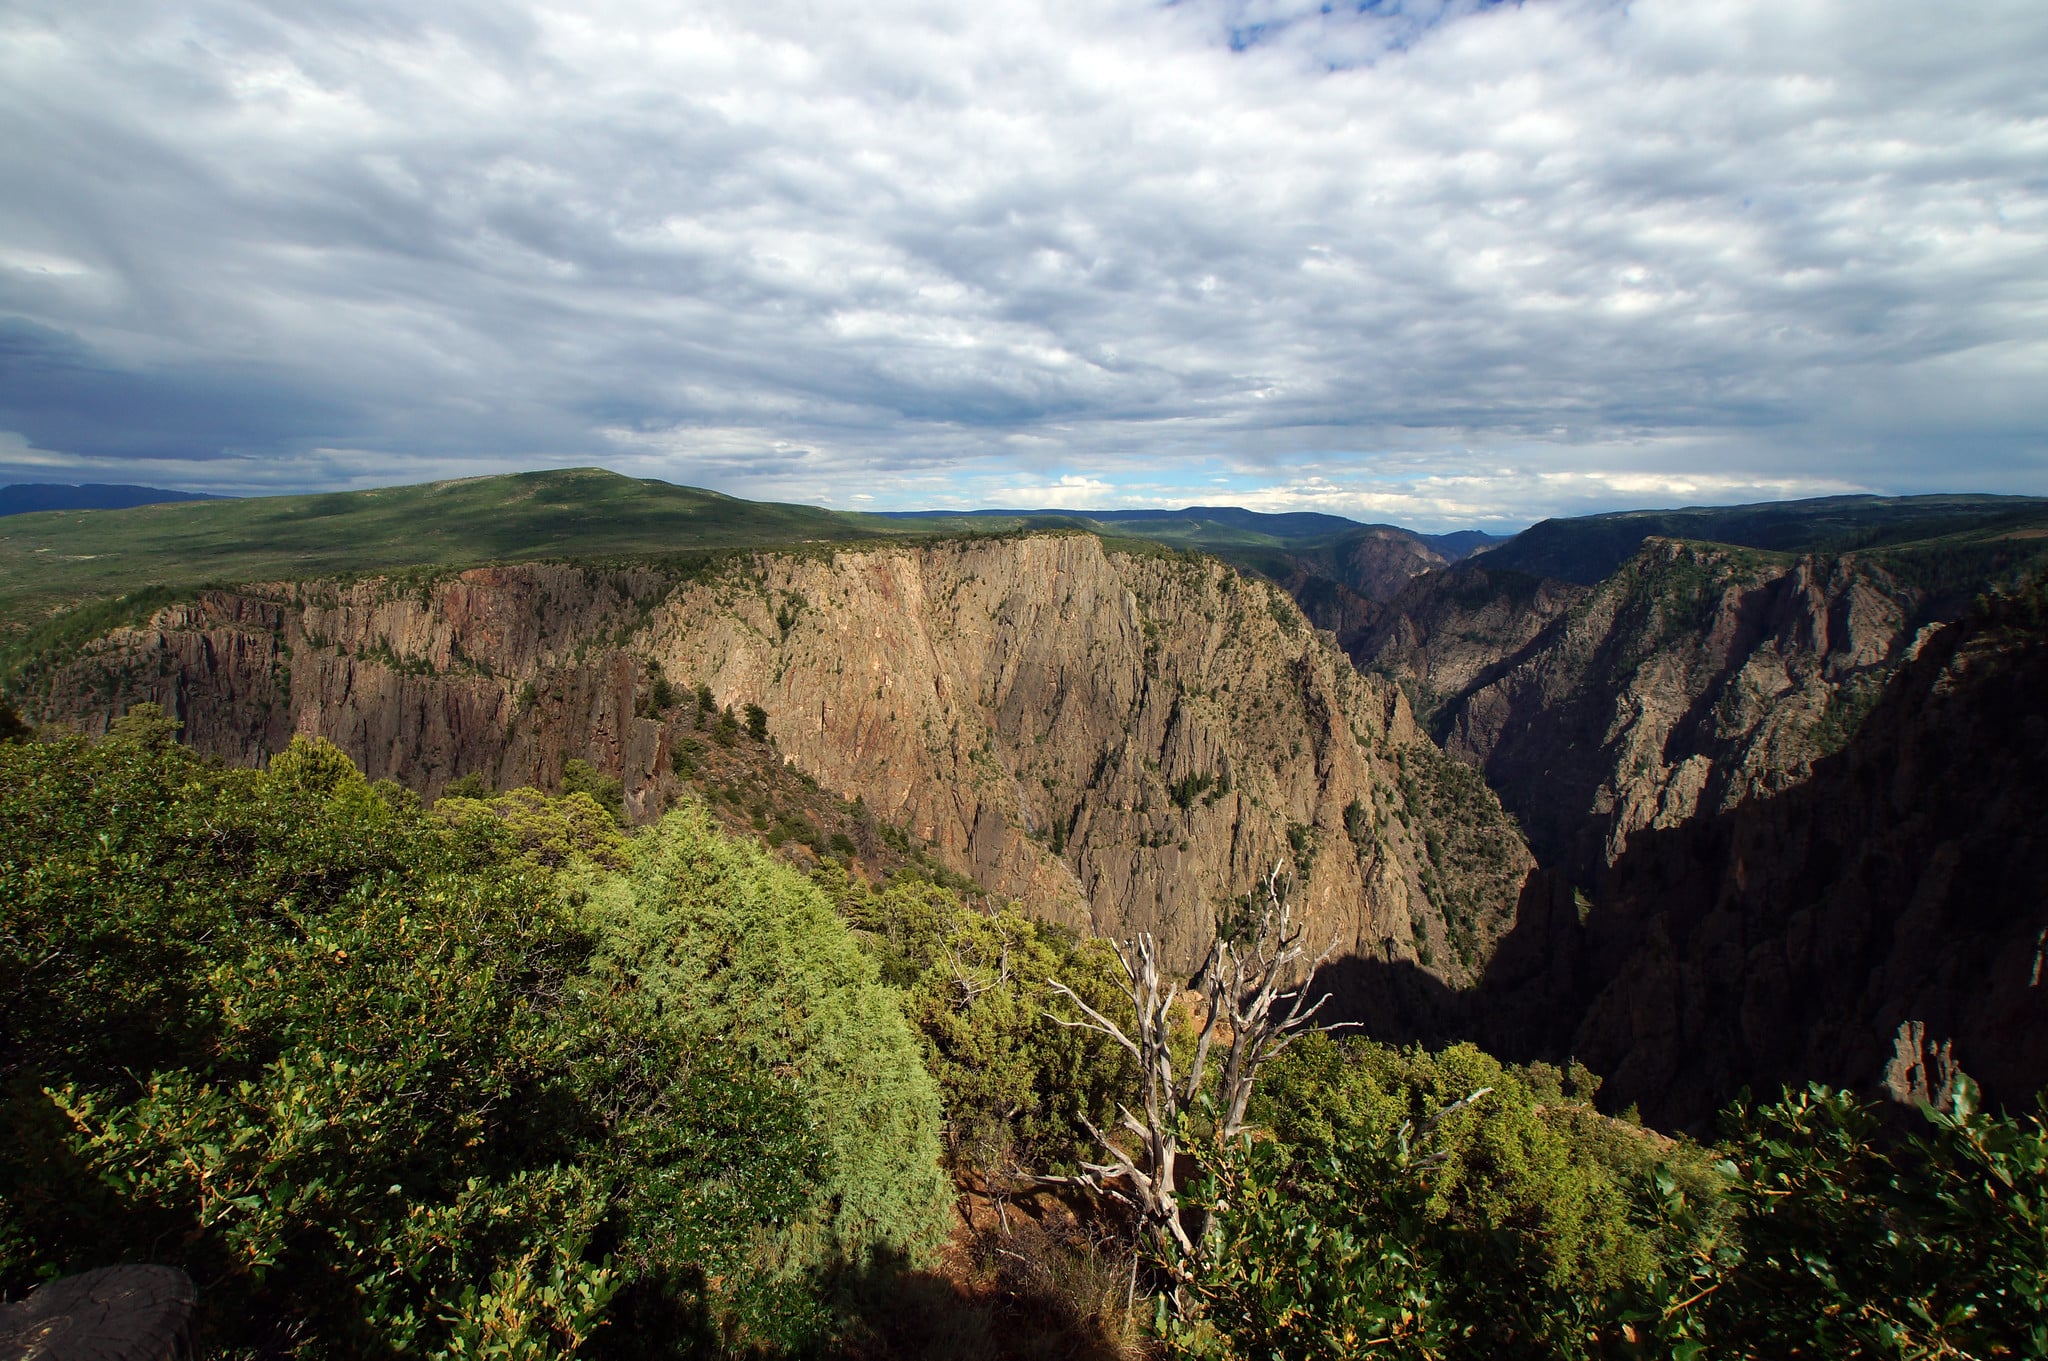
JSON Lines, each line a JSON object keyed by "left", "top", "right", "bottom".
{"left": 0, "top": 469, "right": 1425, "bottom": 675}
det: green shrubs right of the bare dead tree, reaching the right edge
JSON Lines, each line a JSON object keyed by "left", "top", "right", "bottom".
{"left": 1167, "top": 1040, "right": 2048, "bottom": 1361}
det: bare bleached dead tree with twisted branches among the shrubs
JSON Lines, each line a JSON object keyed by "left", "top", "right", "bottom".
{"left": 1047, "top": 866, "right": 1337, "bottom": 1261}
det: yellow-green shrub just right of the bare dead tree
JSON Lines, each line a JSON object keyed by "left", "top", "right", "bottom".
{"left": 1237, "top": 1036, "right": 1724, "bottom": 1357}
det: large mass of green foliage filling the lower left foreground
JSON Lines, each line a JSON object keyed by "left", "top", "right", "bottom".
{"left": 0, "top": 728, "right": 944, "bottom": 1357}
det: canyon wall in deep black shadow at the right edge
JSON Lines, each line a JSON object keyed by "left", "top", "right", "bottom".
{"left": 1479, "top": 573, "right": 2048, "bottom": 1126}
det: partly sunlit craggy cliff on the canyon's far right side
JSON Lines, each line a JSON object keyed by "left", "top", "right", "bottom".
{"left": 1374, "top": 538, "right": 1915, "bottom": 882}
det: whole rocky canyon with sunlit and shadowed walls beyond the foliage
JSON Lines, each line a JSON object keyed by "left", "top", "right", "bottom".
{"left": 10, "top": 483, "right": 2048, "bottom": 1130}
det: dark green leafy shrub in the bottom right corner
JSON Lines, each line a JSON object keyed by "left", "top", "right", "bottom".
{"left": 1645, "top": 1079, "right": 2048, "bottom": 1361}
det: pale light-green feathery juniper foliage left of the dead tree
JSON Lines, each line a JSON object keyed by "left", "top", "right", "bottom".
{"left": 578, "top": 804, "right": 950, "bottom": 1277}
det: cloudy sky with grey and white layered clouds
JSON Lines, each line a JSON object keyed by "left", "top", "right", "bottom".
{"left": 0, "top": 0, "right": 2048, "bottom": 528}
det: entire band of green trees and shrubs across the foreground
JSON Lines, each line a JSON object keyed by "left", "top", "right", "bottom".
{"left": 0, "top": 706, "right": 2048, "bottom": 1357}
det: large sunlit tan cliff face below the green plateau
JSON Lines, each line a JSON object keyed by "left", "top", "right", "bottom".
{"left": 25, "top": 534, "right": 1532, "bottom": 986}
